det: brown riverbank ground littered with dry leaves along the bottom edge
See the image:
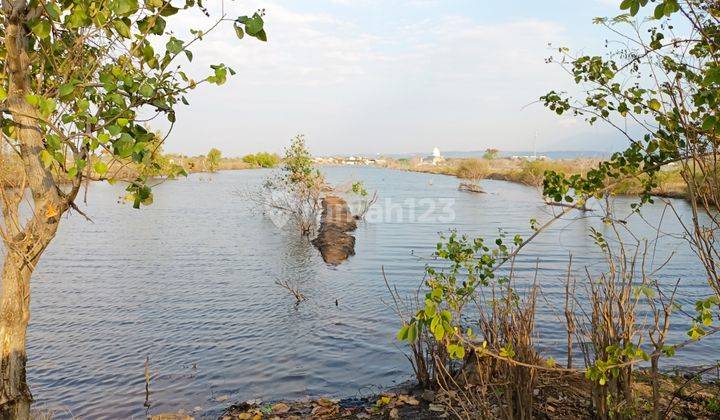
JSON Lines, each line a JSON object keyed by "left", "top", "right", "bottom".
{"left": 211, "top": 371, "right": 720, "bottom": 420}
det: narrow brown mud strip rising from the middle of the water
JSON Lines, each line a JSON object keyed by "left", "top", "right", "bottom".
{"left": 312, "top": 196, "right": 357, "bottom": 265}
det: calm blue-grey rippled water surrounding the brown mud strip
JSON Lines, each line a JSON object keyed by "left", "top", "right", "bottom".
{"left": 12, "top": 168, "right": 717, "bottom": 418}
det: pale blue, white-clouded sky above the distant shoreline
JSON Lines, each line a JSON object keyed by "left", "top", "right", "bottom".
{"left": 153, "top": 0, "right": 623, "bottom": 156}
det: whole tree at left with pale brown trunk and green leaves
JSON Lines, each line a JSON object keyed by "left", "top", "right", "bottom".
{"left": 0, "top": 0, "right": 266, "bottom": 418}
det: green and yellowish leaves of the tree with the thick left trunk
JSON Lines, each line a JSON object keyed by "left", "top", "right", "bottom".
{"left": 0, "top": 0, "right": 265, "bottom": 208}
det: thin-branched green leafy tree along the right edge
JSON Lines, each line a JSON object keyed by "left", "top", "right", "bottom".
{"left": 541, "top": 0, "right": 720, "bottom": 418}
